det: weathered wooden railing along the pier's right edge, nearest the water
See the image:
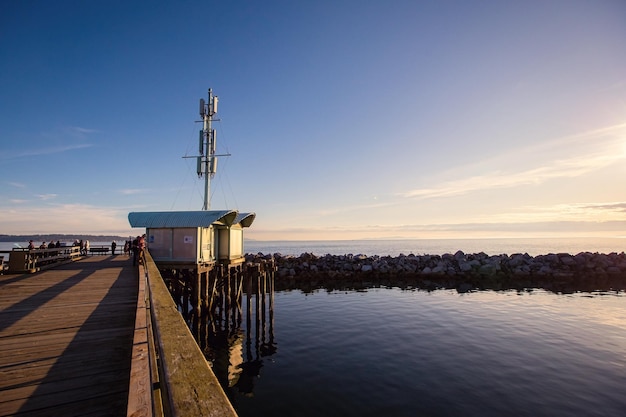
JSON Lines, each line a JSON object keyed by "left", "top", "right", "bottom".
{"left": 127, "top": 251, "right": 237, "bottom": 417}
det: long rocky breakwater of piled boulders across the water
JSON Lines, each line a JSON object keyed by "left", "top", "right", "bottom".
{"left": 246, "top": 251, "right": 626, "bottom": 292}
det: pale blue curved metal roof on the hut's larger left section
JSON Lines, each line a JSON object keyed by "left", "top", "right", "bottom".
{"left": 128, "top": 210, "right": 236, "bottom": 228}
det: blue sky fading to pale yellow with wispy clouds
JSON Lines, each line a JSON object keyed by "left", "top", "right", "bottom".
{"left": 0, "top": 0, "right": 626, "bottom": 240}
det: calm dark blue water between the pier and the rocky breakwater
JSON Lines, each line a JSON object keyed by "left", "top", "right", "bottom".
{"left": 205, "top": 288, "right": 626, "bottom": 417}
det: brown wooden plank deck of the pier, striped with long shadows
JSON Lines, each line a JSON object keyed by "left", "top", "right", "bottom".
{"left": 0, "top": 255, "right": 138, "bottom": 416}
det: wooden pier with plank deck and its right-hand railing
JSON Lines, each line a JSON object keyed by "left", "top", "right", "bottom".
{"left": 0, "top": 252, "right": 241, "bottom": 417}
